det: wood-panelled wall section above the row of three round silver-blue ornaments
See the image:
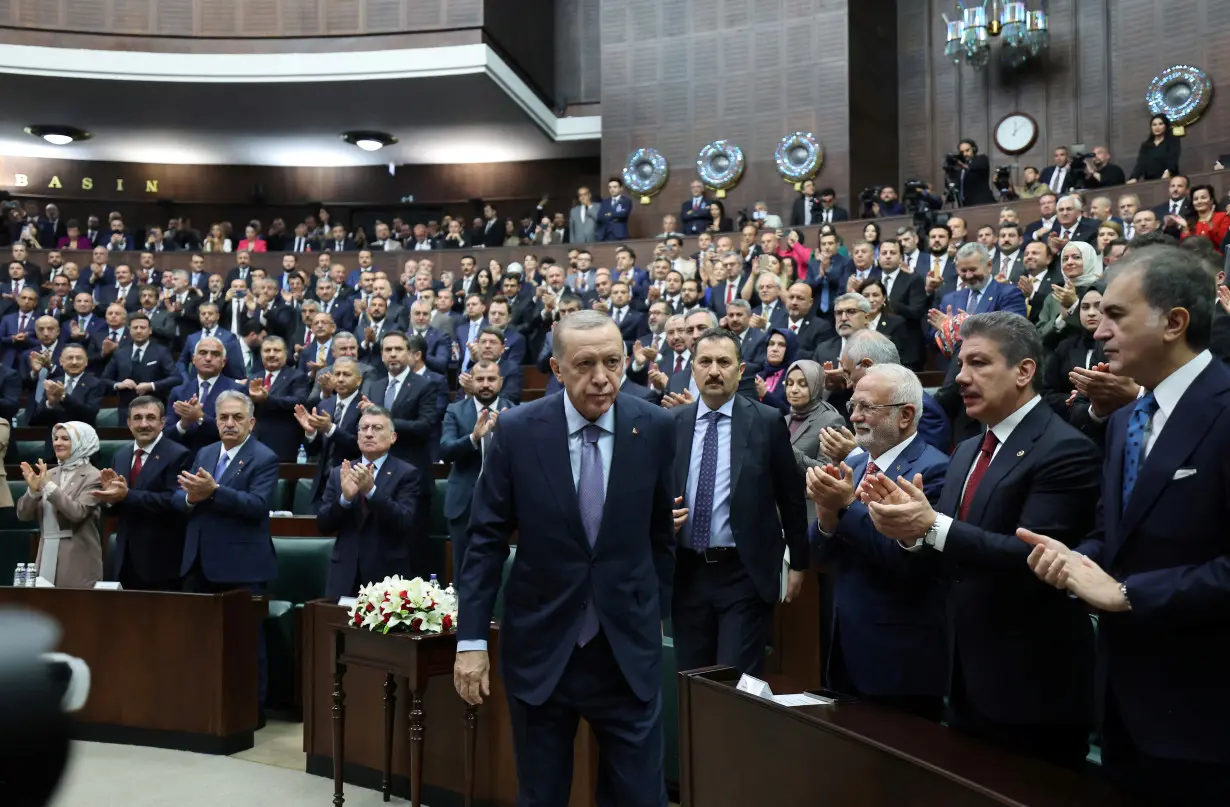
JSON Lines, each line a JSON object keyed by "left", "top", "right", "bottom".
{"left": 600, "top": 0, "right": 854, "bottom": 234}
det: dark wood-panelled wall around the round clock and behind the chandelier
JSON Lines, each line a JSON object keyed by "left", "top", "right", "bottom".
{"left": 897, "top": 0, "right": 1230, "bottom": 191}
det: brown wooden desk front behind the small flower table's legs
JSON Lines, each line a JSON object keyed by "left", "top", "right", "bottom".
{"left": 303, "top": 600, "right": 598, "bottom": 807}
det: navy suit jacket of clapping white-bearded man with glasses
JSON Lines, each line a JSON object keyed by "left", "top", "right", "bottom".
{"left": 811, "top": 435, "right": 948, "bottom": 696}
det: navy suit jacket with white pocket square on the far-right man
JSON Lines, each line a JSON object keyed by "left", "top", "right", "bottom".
{"left": 1076, "top": 358, "right": 1230, "bottom": 764}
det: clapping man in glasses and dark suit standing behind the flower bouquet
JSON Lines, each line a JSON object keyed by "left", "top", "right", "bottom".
{"left": 316, "top": 406, "right": 431, "bottom": 599}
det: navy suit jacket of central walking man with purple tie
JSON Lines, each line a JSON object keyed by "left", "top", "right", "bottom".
{"left": 458, "top": 392, "right": 675, "bottom": 706}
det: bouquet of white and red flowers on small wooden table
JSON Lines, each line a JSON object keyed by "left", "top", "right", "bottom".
{"left": 351, "top": 577, "right": 458, "bottom": 634}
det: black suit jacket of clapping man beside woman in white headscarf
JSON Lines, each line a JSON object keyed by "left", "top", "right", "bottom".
{"left": 107, "top": 439, "right": 192, "bottom": 582}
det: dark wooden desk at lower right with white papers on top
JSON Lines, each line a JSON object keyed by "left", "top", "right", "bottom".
{"left": 679, "top": 667, "right": 1133, "bottom": 807}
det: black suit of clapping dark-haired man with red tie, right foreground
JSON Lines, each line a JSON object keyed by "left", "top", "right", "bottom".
{"left": 921, "top": 400, "right": 1101, "bottom": 726}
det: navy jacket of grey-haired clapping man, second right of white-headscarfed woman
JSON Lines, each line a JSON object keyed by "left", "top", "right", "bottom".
{"left": 171, "top": 437, "right": 278, "bottom": 583}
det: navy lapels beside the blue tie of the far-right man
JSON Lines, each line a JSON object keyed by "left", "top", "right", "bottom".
{"left": 1113, "top": 366, "right": 1230, "bottom": 556}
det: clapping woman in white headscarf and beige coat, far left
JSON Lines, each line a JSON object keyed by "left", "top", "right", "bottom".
{"left": 17, "top": 421, "right": 102, "bottom": 588}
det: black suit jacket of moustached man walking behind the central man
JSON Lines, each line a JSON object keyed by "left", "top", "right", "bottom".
{"left": 672, "top": 395, "right": 809, "bottom": 603}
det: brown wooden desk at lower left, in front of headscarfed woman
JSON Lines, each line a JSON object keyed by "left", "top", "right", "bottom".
{"left": 0, "top": 588, "right": 257, "bottom": 754}
